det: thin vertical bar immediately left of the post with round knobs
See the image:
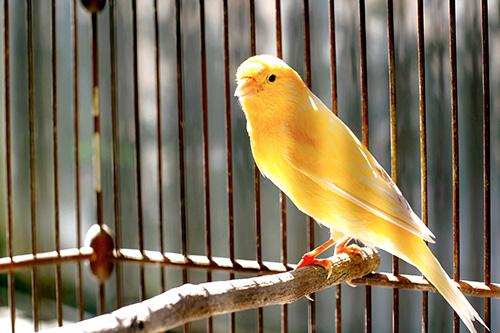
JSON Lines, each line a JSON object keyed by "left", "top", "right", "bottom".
{"left": 71, "top": 0, "right": 84, "bottom": 320}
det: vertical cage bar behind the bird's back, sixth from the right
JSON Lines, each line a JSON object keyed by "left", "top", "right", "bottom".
{"left": 328, "top": 0, "right": 342, "bottom": 333}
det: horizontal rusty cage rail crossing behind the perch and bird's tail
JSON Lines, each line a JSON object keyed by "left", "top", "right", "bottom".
{"left": 0, "top": 247, "right": 500, "bottom": 299}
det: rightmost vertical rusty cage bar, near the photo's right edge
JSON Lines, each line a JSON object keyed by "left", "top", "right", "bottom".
{"left": 481, "top": 0, "right": 491, "bottom": 332}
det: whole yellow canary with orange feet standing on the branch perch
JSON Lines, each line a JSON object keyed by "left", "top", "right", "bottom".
{"left": 235, "top": 55, "right": 486, "bottom": 332}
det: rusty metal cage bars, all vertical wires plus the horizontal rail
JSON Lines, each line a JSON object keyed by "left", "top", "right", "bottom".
{"left": 0, "top": 0, "right": 500, "bottom": 332}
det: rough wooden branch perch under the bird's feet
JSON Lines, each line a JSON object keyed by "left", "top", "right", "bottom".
{"left": 46, "top": 248, "right": 380, "bottom": 333}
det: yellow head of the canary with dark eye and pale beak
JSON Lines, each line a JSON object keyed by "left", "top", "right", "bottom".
{"left": 234, "top": 55, "right": 305, "bottom": 104}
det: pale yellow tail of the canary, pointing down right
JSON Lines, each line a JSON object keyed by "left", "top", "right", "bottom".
{"left": 406, "top": 239, "right": 489, "bottom": 333}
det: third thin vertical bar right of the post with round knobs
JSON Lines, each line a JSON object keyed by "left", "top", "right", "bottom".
{"left": 153, "top": 0, "right": 165, "bottom": 292}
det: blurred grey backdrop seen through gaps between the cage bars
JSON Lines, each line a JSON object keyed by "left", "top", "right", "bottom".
{"left": 0, "top": 0, "right": 500, "bottom": 332}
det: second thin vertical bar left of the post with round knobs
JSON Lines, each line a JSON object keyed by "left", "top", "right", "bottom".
{"left": 51, "top": 0, "right": 63, "bottom": 326}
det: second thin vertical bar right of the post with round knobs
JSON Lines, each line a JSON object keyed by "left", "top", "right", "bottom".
{"left": 132, "top": 0, "right": 146, "bottom": 300}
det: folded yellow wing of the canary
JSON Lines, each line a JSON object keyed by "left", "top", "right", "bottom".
{"left": 284, "top": 93, "right": 435, "bottom": 243}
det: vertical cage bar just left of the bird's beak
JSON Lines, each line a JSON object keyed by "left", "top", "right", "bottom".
{"left": 222, "top": 0, "right": 236, "bottom": 332}
